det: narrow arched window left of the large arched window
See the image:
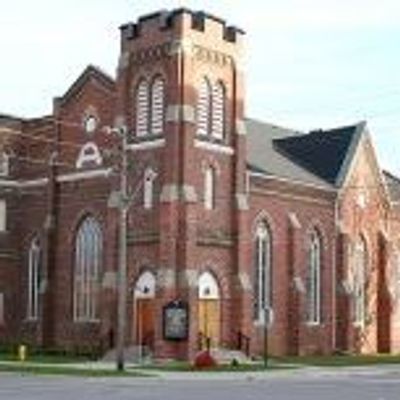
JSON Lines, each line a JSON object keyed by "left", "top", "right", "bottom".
{"left": 27, "top": 237, "right": 42, "bottom": 319}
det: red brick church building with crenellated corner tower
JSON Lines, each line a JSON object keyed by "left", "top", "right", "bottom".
{"left": 0, "top": 9, "right": 400, "bottom": 358}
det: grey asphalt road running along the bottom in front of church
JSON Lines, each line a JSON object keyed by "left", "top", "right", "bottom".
{"left": 0, "top": 366, "right": 400, "bottom": 400}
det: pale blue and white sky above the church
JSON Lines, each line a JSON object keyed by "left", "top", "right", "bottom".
{"left": 0, "top": 0, "right": 400, "bottom": 175}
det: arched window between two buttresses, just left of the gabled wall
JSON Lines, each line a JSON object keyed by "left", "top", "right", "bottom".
{"left": 306, "top": 230, "right": 322, "bottom": 324}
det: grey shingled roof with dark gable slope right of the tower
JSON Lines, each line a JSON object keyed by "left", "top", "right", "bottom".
{"left": 246, "top": 119, "right": 365, "bottom": 188}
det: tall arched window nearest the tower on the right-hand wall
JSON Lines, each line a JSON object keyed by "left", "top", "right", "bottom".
{"left": 254, "top": 222, "right": 272, "bottom": 321}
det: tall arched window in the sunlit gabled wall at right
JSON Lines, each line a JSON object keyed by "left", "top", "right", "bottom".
{"left": 353, "top": 238, "right": 368, "bottom": 326}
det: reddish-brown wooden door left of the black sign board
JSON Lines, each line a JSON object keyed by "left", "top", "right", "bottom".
{"left": 135, "top": 299, "right": 155, "bottom": 349}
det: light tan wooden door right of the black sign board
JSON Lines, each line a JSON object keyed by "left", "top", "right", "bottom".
{"left": 199, "top": 299, "right": 221, "bottom": 348}
